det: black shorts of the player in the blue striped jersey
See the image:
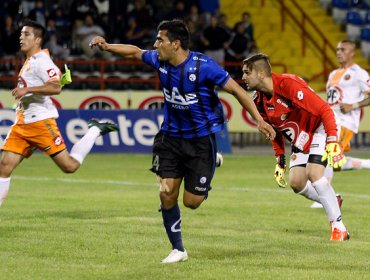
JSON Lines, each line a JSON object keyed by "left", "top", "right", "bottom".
{"left": 151, "top": 132, "right": 217, "bottom": 196}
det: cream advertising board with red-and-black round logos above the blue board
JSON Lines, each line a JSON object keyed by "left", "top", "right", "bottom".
{"left": 0, "top": 90, "right": 370, "bottom": 132}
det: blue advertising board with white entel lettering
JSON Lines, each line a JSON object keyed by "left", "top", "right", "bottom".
{"left": 0, "top": 109, "right": 231, "bottom": 153}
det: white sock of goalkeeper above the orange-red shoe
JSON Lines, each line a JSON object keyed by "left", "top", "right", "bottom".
{"left": 312, "top": 177, "right": 346, "bottom": 231}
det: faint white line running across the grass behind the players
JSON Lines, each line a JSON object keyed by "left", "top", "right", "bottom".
{"left": 12, "top": 176, "right": 370, "bottom": 199}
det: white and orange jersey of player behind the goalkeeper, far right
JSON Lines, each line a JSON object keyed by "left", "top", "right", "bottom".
{"left": 326, "top": 64, "right": 370, "bottom": 133}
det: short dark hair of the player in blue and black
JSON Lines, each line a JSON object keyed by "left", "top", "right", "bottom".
{"left": 157, "top": 19, "right": 190, "bottom": 50}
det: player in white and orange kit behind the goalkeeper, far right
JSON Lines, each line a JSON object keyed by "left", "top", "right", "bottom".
{"left": 311, "top": 40, "right": 370, "bottom": 208}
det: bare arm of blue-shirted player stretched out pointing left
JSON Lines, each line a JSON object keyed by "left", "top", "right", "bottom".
{"left": 89, "top": 36, "right": 144, "bottom": 60}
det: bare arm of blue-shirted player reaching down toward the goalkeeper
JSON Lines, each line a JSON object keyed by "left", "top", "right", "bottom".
{"left": 224, "top": 78, "right": 276, "bottom": 140}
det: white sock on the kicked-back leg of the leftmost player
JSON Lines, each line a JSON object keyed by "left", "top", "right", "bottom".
{"left": 70, "top": 126, "right": 100, "bottom": 164}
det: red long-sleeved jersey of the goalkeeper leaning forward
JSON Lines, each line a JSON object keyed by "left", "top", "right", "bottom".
{"left": 253, "top": 74, "right": 337, "bottom": 155}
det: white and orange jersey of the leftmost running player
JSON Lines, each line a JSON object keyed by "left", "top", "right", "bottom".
{"left": 16, "top": 49, "right": 61, "bottom": 124}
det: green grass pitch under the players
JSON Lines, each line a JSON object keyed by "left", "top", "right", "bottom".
{"left": 0, "top": 154, "right": 370, "bottom": 279}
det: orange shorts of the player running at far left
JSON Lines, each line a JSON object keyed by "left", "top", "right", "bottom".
{"left": 1, "top": 119, "right": 66, "bottom": 158}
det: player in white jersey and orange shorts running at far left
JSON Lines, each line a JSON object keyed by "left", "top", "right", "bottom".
{"left": 0, "top": 20, "right": 118, "bottom": 205}
